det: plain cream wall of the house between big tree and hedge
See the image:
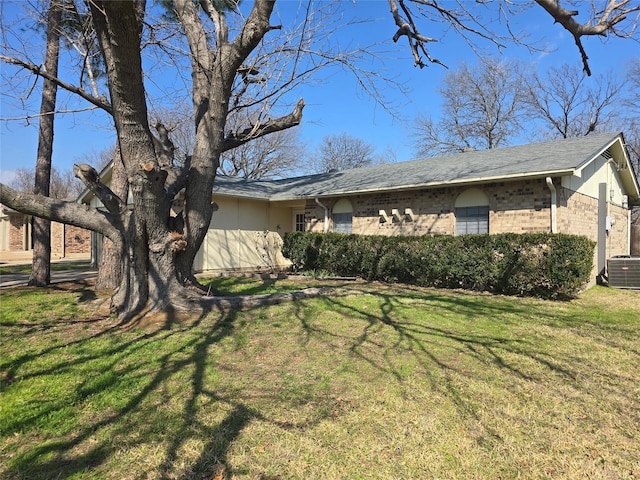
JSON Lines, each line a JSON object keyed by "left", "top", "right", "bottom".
{"left": 193, "top": 197, "right": 293, "bottom": 271}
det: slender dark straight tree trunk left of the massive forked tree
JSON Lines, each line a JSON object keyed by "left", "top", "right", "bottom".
{"left": 28, "top": 0, "right": 64, "bottom": 287}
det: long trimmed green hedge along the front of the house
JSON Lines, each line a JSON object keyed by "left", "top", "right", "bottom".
{"left": 282, "top": 232, "right": 595, "bottom": 299}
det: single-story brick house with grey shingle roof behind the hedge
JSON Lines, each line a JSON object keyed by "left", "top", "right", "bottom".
{"left": 80, "top": 133, "right": 640, "bottom": 278}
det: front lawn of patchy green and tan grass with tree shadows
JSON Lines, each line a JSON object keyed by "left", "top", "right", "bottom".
{"left": 0, "top": 279, "right": 640, "bottom": 480}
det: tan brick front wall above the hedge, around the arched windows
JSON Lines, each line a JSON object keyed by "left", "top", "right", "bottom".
{"left": 305, "top": 179, "right": 551, "bottom": 236}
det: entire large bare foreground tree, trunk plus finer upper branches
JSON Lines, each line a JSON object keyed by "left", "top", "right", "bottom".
{"left": 0, "top": 0, "right": 390, "bottom": 319}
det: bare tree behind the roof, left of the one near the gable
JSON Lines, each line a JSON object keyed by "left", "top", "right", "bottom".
{"left": 413, "top": 59, "right": 523, "bottom": 155}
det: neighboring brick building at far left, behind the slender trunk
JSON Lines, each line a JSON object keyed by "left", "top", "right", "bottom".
{"left": 0, "top": 205, "right": 91, "bottom": 258}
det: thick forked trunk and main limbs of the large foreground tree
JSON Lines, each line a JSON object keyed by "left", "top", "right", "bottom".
{"left": 0, "top": 0, "right": 304, "bottom": 320}
